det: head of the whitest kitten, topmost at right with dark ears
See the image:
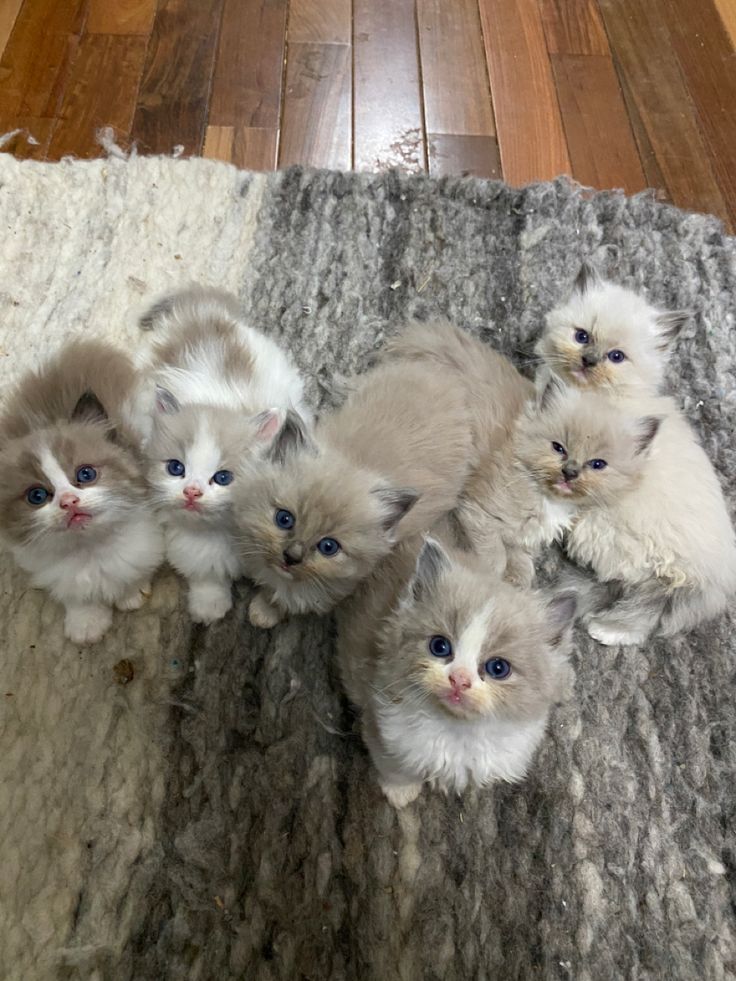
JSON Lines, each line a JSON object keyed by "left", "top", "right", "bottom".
{"left": 535, "top": 263, "right": 689, "bottom": 395}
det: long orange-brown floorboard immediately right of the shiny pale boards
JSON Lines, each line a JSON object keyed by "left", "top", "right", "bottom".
{"left": 479, "top": 0, "right": 571, "bottom": 185}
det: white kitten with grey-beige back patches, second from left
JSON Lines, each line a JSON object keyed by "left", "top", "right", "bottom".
{"left": 141, "top": 287, "right": 306, "bottom": 623}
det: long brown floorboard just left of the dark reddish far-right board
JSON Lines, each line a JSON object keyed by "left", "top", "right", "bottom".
{"left": 599, "top": 0, "right": 729, "bottom": 221}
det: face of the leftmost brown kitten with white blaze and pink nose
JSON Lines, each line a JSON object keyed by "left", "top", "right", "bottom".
{"left": 0, "top": 422, "right": 145, "bottom": 546}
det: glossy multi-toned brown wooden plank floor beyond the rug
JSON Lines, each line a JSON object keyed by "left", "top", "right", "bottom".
{"left": 0, "top": 0, "right": 736, "bottom": 228}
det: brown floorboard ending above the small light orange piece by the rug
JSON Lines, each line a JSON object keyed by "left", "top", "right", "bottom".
{"left": 208, "top": 0, "right": 288, "bottom": 129}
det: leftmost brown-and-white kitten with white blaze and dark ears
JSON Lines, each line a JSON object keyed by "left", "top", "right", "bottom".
{"left": 0, "top": 341, "right": 163, "bottom": 643}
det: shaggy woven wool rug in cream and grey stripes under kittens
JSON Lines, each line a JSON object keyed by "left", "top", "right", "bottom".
{"left": 0, "top": 147, "right": 736, "bottom": 981}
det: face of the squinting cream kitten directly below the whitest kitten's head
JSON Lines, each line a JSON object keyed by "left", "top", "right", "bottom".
{"left": 515, "top": 380, "right": 661, "bottom": 504}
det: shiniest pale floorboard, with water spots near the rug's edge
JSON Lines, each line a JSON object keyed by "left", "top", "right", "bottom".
{"left": 353, "top": 0, "right": 426, "bottom": 172}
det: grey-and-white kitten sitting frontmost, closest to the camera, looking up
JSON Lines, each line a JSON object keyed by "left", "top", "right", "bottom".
{"left": 338, "top": 534, "right": 575, "bottom": 807}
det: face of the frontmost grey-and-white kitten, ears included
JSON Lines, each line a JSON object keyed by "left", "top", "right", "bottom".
{"left": 376, "top": 539, "right": 575, "bottom": 722}
